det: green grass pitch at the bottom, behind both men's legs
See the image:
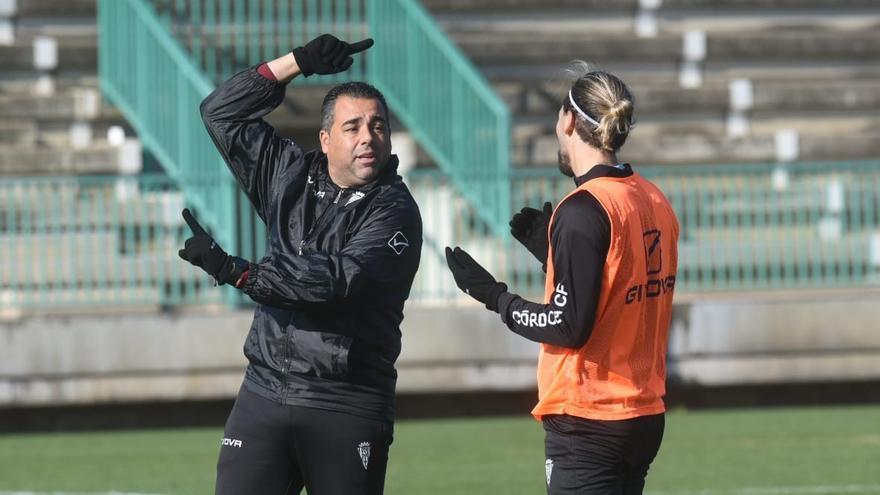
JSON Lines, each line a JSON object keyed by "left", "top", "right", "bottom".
{"left": 0, "top": 405, "right": 880, "bottom": 495}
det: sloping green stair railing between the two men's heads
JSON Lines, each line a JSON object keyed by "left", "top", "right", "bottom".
{"left": 367, "top": 0, "right": 510, "bottom": 235}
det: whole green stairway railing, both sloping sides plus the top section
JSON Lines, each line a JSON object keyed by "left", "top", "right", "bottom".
{"left": 98, "top": 0, "right": 510, "bottom": 282}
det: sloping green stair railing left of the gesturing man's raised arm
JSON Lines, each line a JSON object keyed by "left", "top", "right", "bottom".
{"left": 98, "top": 0, "right": 265, "bottom": 286}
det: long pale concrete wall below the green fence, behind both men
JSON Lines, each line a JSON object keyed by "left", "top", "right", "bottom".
{"left": 0, "top": 291, "right": 880, "bottom": 407}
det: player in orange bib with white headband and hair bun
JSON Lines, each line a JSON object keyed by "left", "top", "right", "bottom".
{"left": 446, "top": 64, "right": 679, "bottom": 495}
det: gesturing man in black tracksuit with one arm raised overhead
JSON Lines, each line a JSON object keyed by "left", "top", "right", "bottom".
{"left": 180, "top": 35, "right": 422, "bottom": 495}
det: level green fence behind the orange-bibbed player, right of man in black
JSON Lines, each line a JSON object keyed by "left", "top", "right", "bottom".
{"left": 408, "top": 160, "right": 880, "bottom": 303}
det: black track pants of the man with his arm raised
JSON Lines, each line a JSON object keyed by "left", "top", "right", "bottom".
{"left": 215, "top": 387, "right": 393, "bottom": 495}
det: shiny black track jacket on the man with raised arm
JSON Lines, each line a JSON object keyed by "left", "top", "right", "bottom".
{"left": 201, "top": 68, "right": 422, "bottom": 421}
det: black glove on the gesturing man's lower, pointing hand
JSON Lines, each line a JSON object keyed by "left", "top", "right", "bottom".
{"left": 177, "top": 208, "right": 248, "bottom": 285}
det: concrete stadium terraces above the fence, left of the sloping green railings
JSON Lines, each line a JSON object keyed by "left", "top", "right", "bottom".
{"left": 0, "top": 0, "right": 131, "bottom": 176}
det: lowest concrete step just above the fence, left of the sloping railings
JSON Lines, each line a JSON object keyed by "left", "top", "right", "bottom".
{"left": 0, "top": 141, "right": 119, "bottom": 176}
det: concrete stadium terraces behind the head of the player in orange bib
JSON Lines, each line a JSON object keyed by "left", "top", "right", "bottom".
{"left": 423, "top": 0, "right": 880, "bottom": 166}
